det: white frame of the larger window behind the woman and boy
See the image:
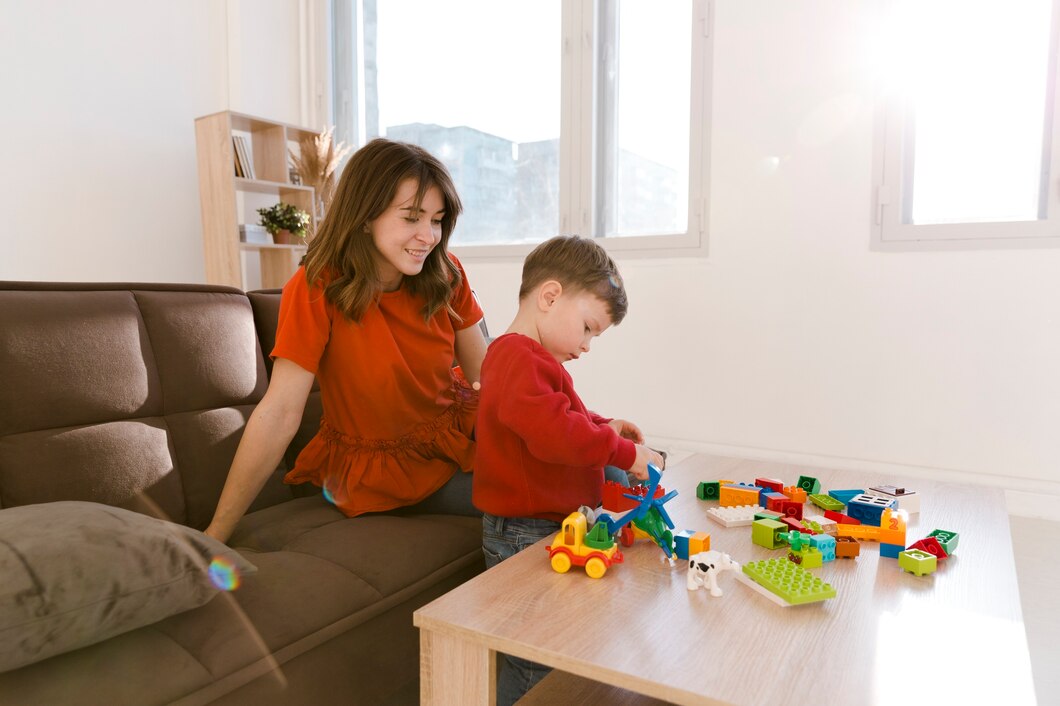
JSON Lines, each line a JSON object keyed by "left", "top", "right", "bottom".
{"left": 333, "top": 0, "right": 713, "bottom": 261}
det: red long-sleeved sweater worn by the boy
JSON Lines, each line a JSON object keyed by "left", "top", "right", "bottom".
{"left": 473, "top": 334, "right": 637, "bottom": 520}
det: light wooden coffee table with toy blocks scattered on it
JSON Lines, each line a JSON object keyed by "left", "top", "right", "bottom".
{"left": 413, "top": 455, "right": 1034, "bottom": 706}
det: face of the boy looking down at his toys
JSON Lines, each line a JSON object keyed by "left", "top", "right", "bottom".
{"left": 537, "top": 290, "right": 611, "bottom": 365}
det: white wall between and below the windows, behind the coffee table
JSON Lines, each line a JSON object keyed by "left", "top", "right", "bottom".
{"left": 464, "top": 0, "right": 1060, "bottom": 514}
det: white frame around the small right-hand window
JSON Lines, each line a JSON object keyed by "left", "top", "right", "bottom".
{"left": 870, "top": 0, "right": 1060, "bottom": 251}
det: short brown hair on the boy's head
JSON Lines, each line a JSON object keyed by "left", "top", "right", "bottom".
{"left": 519, "top": 235, "right": 629, "bottom": 325}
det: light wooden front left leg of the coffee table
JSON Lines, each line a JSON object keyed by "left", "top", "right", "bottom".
{"left": 420, "top": 628, "right": 497, "bottom": 706}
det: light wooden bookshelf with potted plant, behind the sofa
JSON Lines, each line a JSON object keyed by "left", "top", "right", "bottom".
{"left": 195, "top": 110, "right": 317, "bottom": 289}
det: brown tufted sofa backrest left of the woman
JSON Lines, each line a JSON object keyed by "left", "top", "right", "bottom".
{"left": 0, "top": 282, "right": 305, "bottom": 529}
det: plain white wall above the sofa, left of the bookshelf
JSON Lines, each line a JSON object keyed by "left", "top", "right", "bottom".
{"left": 0, "top": 0, "right": 301, "bottom": 282}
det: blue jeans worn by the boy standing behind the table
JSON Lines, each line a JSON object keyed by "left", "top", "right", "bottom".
{"left": 482, "top": 513, "right": 560, "bottom": 706}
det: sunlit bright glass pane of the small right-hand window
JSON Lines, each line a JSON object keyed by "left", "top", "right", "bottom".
{"left": 898, "top": 0, "right": 1052, "bottom": 225}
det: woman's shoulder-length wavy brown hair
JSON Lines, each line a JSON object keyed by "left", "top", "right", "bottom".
{"left": 304, "top": 138, "right": 462, "bottom": 321}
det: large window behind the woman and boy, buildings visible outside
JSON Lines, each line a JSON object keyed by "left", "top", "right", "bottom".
{"left": 333, "top": 0, "right": 710, "bottom": 253}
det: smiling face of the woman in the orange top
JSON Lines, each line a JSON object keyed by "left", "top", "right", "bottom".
{"left": 368, "top": 179, "right": 445, "bottom": 292}
